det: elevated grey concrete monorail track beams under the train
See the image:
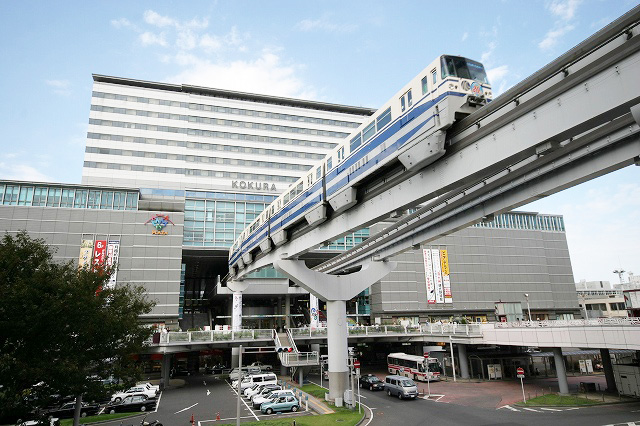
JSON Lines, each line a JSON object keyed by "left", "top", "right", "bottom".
{"left": 238, "top": 6, "right": 640, "bottom": 278}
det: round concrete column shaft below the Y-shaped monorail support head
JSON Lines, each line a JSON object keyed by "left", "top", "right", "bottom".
{"left": 327, "top": 300, "right": 349, "bottom": 399}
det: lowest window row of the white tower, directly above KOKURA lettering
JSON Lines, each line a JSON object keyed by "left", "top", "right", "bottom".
{"left": 84, "top": 161, "right": 298, "bottom": 183}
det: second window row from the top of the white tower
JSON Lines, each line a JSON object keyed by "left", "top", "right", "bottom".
{"left": 91, "top": 105, "right": 349, "bottom": 139}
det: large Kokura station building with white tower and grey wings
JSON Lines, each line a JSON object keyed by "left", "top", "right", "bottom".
{"left": 0, "top": 75, "right": 579, "bottom": 330}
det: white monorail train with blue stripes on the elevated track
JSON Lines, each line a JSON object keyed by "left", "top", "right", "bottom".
{"left": 229, "top": 55, "right": 491, "bottom": 276}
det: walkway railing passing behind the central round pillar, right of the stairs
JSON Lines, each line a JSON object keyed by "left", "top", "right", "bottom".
{"left": 289, "top": 323, "right": 482, "bottom": 338}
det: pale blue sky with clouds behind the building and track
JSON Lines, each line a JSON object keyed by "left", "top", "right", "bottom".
{"left": 0, "top": 0, "right": 640, "bottom": 282}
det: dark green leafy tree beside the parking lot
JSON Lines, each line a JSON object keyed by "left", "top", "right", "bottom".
{"left": 0, "top": 231, "right": 154, "bottom": 424}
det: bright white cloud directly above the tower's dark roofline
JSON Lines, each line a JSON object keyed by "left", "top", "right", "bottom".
{"left": 168, "top": 50, "right": 317, "bottom": 99}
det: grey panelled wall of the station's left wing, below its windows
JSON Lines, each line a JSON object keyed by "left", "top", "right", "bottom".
{"left": 0, "top": 205, "right": 184, "bottom": 321}
